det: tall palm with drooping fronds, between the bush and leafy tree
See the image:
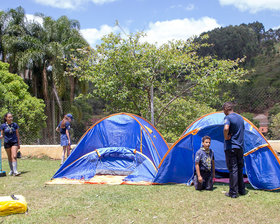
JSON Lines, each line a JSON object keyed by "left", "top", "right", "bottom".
{"left": 16, "top": 15, "right": 88, "bottom": 142}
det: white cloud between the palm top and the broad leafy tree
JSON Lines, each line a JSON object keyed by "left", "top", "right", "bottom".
{"left": 81, "top": 25, "right": 120, "bottom": 47}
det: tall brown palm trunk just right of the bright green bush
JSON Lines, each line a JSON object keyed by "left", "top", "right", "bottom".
{"left": 42, "top": 63, "right": 52, "bottom": 142}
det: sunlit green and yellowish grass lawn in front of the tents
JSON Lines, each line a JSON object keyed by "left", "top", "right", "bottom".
{"left": 0, "top": 159, "right": 280, "bottom": 224}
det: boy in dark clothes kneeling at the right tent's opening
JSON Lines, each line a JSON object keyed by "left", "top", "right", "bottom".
{"left": 194, "top": 136, "right": 215, "bottom": 190}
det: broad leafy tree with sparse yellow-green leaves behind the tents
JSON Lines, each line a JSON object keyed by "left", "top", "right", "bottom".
{"left": 68, "top": 33, "right": 246, "bottom": 135}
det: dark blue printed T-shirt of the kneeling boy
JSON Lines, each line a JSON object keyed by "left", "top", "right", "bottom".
{"left": 195, "top": 148, "right": 214, "bottom": 171}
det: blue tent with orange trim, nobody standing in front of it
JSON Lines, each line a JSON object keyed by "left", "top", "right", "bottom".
{"left": 53, "top": 113, "right": 168, "bottom": 182}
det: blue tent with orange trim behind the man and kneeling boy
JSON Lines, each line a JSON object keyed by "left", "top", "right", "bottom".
{"left": 154, "top": 112, "right": 280, "bottom": 190}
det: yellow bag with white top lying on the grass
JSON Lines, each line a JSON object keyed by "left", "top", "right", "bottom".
{"left": 0, "top": 195, "right": 27, "bottom": 216}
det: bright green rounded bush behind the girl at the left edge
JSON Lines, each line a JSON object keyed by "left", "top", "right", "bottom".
{"left": 0, "top": 62, "right": 46, "bottom": 144}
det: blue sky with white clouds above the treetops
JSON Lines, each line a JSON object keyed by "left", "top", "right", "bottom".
{"left": 0, "top": 0, "right": 280, "bottom": 47}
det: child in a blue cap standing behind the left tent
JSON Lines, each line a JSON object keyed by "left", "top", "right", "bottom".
{"left": 56, "top": 114, "right": 73, "bottom": 165}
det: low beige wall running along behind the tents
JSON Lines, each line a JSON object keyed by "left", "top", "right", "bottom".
{"left": 2, "top": 140, "right": 280, "bottom": 159}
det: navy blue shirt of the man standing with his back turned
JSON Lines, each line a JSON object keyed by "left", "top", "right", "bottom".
{"left": 224, "top": 113, "right": 245, "bottom": 150}
